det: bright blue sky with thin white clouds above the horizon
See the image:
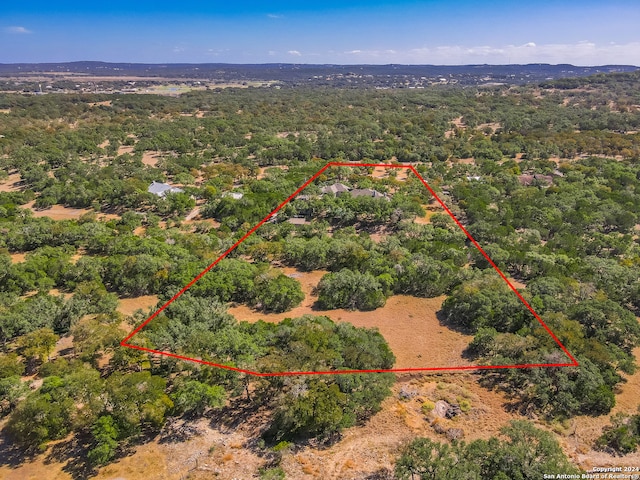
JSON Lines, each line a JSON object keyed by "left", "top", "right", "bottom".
{"left": 0, "top": 0, "right": 640, "bottom": 65}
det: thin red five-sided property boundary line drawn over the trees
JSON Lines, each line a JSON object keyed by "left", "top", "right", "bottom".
{"left": 120, "top": 162, "right": 578, "bottom": 377}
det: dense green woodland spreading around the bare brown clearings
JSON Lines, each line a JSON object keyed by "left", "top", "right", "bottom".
{"left": 0, "top": 69, "right": 640, "bottom": 478}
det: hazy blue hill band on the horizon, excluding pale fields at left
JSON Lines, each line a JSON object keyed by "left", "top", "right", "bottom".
{"left": 0, "top": 61, "right": 638, "bottom": 88}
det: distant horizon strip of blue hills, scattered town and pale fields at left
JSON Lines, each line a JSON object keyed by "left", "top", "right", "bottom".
{"left": 0, "top": 62, "right": 638, "bottom": 96}
